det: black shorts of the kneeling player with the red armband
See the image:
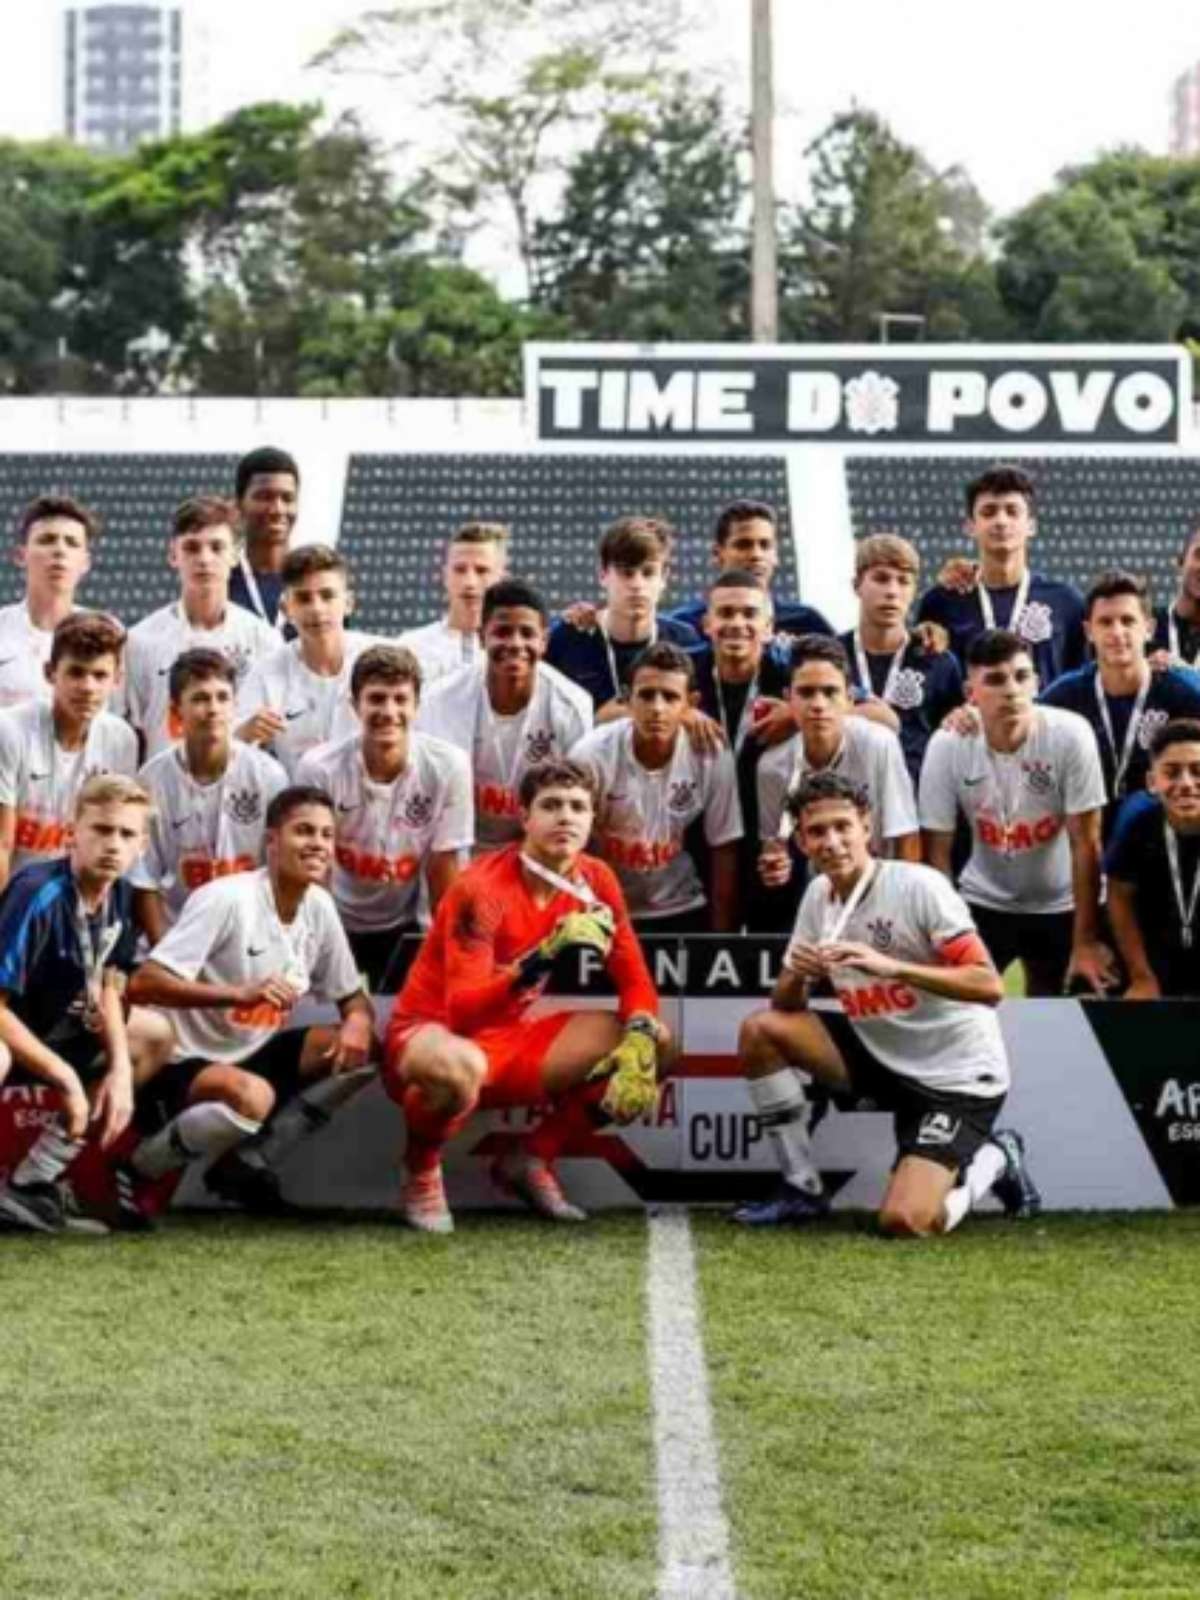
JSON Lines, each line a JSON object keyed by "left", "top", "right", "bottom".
{"left": 821, "top": 1011, "right": 1005, "bottom": 1173}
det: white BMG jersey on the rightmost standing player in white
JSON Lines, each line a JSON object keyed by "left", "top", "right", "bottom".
{"left": 920, "top": 706, "right": 1106, "bottom": 912}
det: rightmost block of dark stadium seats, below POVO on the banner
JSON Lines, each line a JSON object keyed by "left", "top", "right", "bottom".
{"left": 846, "top": 456, "right": 1200, "bottom": 603}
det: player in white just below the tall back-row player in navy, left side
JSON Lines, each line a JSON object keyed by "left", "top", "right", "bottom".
{"left": 237, "top": 544, "right": 381, "bottom": 776}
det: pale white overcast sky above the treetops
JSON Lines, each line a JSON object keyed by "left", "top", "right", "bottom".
{"left": 0, "top": 0, "right": 1200, "bottom": 227}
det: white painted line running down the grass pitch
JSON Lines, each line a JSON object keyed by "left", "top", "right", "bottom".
{"left": 646, "top": 1208, "right": 736, "bottom": 1600}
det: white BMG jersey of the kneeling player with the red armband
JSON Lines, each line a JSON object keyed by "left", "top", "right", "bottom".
{"left": 792, "top": 861, "right": 1010, "bottom": 1098}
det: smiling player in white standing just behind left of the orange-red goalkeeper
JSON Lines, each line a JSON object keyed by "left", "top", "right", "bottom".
{"left": 298, "top": 645, "right": 475, "bottom": 994}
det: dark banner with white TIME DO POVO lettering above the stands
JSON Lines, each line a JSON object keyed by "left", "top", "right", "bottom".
{"left": 525, "top": 344, "right": 1192, "bottom": 448}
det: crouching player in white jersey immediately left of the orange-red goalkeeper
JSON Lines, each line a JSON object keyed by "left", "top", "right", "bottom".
{"left": 130, "top": 787, "right": 374, "bottom": 1213}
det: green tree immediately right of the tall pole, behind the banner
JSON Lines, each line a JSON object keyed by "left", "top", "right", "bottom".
{"left": 781, "top": 109, "right": 1005, "bottom": 341}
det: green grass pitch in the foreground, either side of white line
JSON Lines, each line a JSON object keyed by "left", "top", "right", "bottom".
{"left": 0, "top": 1214, "right": 1200, "bottom": 1600}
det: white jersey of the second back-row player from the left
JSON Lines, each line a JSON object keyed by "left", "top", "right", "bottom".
{"left": 122, "top": 600, "right": 278, "bottom": 760}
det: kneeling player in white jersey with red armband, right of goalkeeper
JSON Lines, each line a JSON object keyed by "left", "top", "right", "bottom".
{"left": 734, "top": 773, "right": 1042, "bottom": 1238}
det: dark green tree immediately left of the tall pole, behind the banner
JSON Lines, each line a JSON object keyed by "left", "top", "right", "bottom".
{"left": 536, "top": 77, "right": 749, "bottom": 341}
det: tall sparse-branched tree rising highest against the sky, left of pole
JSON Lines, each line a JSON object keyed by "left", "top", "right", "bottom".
{"left": 314, "top": 0, "right": 694, "bottom": 290}
